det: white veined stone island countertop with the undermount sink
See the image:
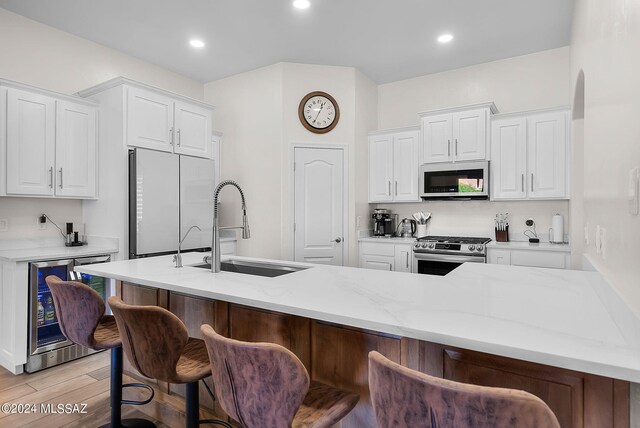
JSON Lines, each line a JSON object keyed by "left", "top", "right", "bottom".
{"left": 76, "top": 253, "right": 640, "bottom": 382}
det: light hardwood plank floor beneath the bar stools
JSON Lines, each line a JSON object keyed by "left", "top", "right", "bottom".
{"left": 0, "top": 351, "right": 222, "bottom": 428}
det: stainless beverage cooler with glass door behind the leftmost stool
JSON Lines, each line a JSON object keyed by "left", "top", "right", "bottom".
{"left": 25, "top": 256, "right": 110, "bottom": 373}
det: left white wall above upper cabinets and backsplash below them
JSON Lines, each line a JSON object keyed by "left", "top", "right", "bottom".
{"left": 0, "top": 8, "right": 204, "bottom": 239}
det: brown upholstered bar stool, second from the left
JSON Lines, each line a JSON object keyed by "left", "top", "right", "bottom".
{"left": 109, "top": 296, "right": 231, "bottom": 428}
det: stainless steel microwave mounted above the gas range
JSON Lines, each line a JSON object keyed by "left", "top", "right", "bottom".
{"left": 420, "top": 161, "right": 489, "bottom": 199}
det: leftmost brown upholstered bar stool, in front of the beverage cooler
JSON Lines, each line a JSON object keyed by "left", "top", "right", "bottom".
{"left": 45, "top": 275, "right": 156, "bottom": 428}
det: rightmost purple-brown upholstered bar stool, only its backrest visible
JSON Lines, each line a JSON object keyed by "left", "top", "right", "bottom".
{"left": 369, "top": 351, "right": 560, "bottom": 428}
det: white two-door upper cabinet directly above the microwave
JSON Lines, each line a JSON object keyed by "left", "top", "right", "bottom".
{"left": 420, "top": 103, "right": 497, "bottom": 163}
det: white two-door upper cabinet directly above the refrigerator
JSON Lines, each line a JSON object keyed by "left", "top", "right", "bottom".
{"left": 126, "top": 86, "right": 213, "bottom": 159}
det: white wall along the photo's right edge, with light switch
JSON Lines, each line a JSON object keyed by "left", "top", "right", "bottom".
{"left": 571, "top": 0, "right": 640, "bottom": 316}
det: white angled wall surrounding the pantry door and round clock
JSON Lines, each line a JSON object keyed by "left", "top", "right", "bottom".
{"left": 205, "top": 63, "right": 376, "bottom": 263}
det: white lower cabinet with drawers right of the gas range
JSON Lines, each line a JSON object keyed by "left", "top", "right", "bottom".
{"left": 487, "top": 248, "right": 571, "bottom": 269}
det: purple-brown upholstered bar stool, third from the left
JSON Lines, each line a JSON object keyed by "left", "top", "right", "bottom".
{"left": 200, "top": 324, "right": 360, "bottom": 428}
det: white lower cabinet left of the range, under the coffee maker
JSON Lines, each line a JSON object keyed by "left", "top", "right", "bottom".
{"left": 359, "top": 240, "right": 412, "bottom": 272}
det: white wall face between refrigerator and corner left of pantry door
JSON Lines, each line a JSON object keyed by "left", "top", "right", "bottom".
{"left": 204, "top": 64, "right": 285, "bottom": 259}
